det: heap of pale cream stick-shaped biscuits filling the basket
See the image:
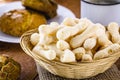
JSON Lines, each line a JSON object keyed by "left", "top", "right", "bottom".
{"left": 30, "top": 18, "right": 120, "bottom": 63}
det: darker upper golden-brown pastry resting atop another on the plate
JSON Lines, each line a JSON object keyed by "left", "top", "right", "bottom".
{"left": 22, "top": 0, "right": 57, "bottom": 18}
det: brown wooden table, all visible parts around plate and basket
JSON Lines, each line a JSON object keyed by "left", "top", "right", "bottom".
{"left": 0, "top": 0, "right": 80, "bottom": 80}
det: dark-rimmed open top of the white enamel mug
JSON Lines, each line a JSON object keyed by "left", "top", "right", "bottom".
{"left": 82, "top": 0, "right": 120, "bottom": 5}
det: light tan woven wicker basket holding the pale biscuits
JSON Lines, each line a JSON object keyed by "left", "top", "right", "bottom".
{"left": 20, "top": 29, "right": 120, "bottom": 79}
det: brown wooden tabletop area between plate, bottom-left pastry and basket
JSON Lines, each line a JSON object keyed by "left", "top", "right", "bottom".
{"left": 0, "top": 42, "right": 37, "bottom": 80}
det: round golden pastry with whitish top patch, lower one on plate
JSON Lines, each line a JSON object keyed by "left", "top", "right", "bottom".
{"left": 0, "top": 9, "right": 46, "bottom": 36}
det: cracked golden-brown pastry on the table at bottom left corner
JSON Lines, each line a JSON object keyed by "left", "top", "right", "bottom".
{"left": 0, "top": 55, "right": 21, "bottom": 80}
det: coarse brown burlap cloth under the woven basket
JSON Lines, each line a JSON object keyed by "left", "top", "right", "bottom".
{"left": 36, "top": 62, "right": 120, "bottom": 80}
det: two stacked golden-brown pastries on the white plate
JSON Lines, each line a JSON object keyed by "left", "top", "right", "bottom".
{"left": 0, "top": 0, "right": 57, "bottom": 37}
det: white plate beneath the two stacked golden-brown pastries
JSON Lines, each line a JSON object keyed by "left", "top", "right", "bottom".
{"left": 0, "top": 1, "right": 75, "bottom": 43}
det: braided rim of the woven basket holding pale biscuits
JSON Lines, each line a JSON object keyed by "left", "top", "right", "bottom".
{"left": 20, "top": 29, "right": 120, "bottom": 66}
